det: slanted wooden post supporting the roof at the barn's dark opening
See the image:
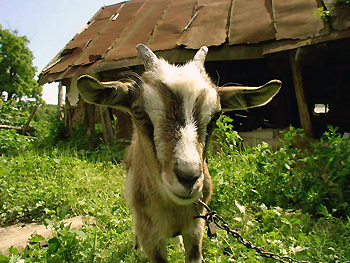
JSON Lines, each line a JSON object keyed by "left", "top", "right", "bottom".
{"left": 289, "top": 50, "right": 313, "bottom": 138}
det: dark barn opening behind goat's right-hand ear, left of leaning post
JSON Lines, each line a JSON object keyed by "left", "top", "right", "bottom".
{"left": 206, "top": 53, "right": 300, "bottom": 131}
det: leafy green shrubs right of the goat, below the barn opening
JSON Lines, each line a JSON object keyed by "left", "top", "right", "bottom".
{"left": 209, "top": 118, "right": 350, "bottom": 217}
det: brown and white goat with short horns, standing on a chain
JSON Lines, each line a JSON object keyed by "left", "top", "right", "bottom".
{"left": 77, "top": 45, "right": 281, "bottom": 263}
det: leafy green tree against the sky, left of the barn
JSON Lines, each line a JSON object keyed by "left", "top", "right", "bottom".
{"left": 0, "top": 24, "right": 42, "bottom": 102}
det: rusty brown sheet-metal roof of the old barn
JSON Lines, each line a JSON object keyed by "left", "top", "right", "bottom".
{"left": 39, "top": 0, "right": 350, "bottom": 84}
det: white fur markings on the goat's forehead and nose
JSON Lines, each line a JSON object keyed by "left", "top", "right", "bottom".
{"left": 144, "top": 60, "right": 217, "bottom": 165}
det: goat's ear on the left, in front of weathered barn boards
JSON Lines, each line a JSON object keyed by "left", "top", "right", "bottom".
{"left": 77, "top": 75, "right": 131, "bottom": 109}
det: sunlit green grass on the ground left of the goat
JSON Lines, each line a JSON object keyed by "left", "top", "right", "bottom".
{"left": 0, "top": 151, "right": 138, "bottom": 262}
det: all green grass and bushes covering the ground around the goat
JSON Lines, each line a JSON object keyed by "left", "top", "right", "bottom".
{"left": 0, "top": 114, "right": 350, "bottom": 263}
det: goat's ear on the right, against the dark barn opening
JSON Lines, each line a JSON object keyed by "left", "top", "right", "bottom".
{"left": 218, "top": 80, "right": 282, "bottom": 111}
